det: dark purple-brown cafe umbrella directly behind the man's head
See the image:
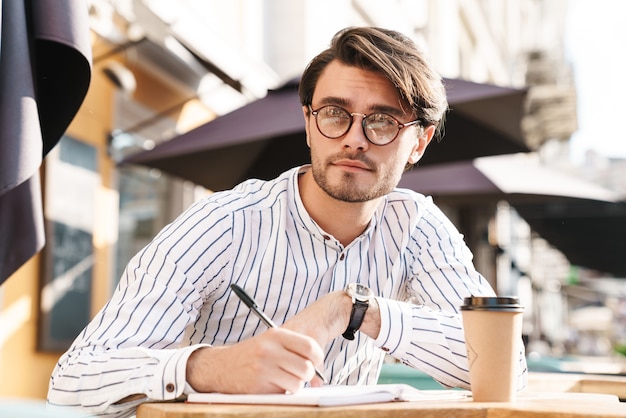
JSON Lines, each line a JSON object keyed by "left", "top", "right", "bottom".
{"left": 120, "top": 79, "right": 529, "bottom": 191}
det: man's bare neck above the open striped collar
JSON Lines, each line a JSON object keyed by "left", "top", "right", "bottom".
{"left": 298, "top": 170, "right": 380, "bottom": 247}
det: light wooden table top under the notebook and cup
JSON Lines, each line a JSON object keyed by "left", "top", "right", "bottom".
{"left": 137, "top": 393, "right": 626, "bottom": 418}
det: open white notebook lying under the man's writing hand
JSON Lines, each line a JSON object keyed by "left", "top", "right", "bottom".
{"left": 187, "top": 383, "right": 471, "bottom": 406}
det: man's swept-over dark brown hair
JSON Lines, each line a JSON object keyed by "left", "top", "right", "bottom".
{"left": 299, "top": 27, "right": 448, "bottom": 140}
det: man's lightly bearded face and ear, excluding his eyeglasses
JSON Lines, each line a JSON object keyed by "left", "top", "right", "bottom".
{"left": 303, "top": 61, "right": 434, "bottom": 202}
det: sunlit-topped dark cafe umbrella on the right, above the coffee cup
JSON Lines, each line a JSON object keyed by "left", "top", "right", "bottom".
{"left": 399, "top": 153, "right": 626, "bottom": 276}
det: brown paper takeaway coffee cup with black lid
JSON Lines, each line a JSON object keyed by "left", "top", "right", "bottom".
{"left": 461, "top": 296, "right": 524, "bottom": 402}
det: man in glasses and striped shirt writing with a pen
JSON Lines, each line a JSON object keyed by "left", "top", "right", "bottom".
{"left": 49, "top": 28, "right": 526, "bottom": 415}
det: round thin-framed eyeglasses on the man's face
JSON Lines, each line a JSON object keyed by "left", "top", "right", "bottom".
{"left": 309, "top": 105, "right": 422, "bottom": 145}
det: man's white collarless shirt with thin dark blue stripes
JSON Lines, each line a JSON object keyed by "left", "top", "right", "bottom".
{"left": 48, "top": 167, "right": 526, "bottom": 416}
